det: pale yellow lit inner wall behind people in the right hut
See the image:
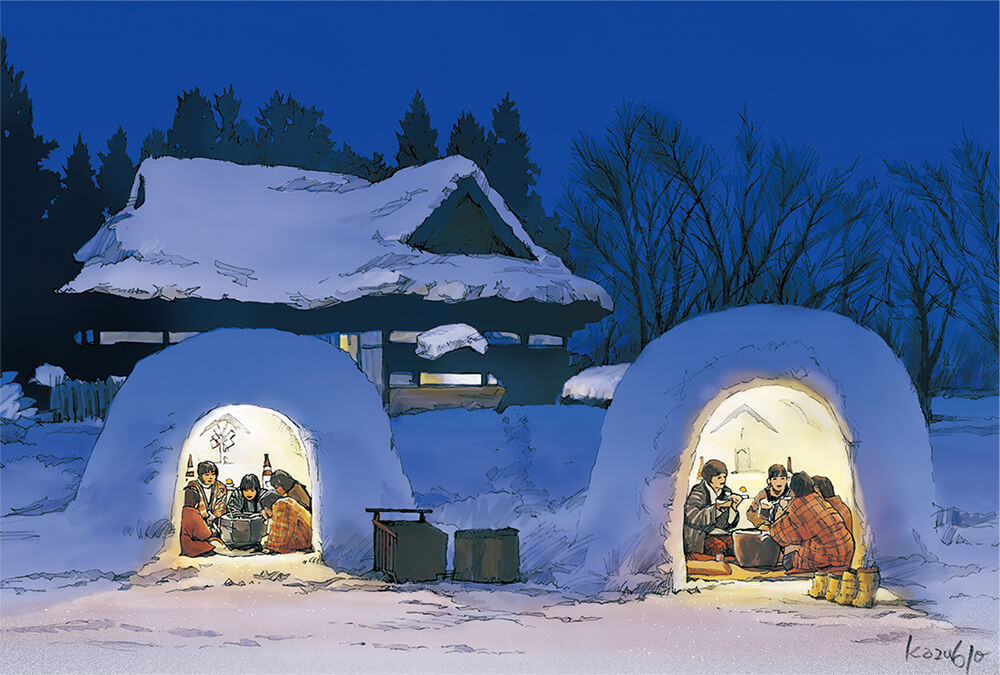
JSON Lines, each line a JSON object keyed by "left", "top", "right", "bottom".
{"left": 687, "top": 384, "right": 863, "bottom": 561}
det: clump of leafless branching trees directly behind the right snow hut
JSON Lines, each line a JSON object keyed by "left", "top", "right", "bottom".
{"left": 561, "top": 105, "right": 881, "bottom": 368}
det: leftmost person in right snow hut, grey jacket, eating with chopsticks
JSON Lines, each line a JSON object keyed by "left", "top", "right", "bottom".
{"left": 684, "top": 459, "right": 743, "bottom": 556}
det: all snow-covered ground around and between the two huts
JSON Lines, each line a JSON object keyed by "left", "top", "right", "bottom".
{"left": 0, "top": 397, "right": 1000, "bottom": 673}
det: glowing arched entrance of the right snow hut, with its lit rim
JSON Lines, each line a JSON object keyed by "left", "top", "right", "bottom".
{"left": 665, "top": 378, "right": 865, "bottom": 579}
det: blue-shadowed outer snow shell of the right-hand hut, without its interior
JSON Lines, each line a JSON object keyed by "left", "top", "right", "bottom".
{"left": 570, "top": 305, "right": 934, "bottom": 589}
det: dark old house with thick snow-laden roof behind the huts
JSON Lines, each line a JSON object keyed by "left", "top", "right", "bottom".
{"left": 60, "top": 156, "right": 611, "bottom": 412}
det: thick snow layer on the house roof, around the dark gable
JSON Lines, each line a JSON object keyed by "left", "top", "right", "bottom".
{"left": 60, "top": 156, "right": 612, "bottom": 309}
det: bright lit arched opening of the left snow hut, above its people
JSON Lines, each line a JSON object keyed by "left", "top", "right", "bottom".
{"left": 164, "top": 405, "right": 322, "bottom": 556}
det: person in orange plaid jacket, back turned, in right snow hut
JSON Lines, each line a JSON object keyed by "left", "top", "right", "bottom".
{"left": 762, "top": 471, "right": 854, "bottom": 572}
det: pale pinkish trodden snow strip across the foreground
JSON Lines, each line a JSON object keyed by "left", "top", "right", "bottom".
{"left": 0, "top": 571, "right": 998, "bottom": 675}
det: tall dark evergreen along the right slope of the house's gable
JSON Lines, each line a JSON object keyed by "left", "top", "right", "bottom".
{"left": 485, "top": 92, "right": 572, "bottom": 265}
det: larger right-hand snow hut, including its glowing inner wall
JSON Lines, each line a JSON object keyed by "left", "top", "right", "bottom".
{"left": 573, "top": 305, "right": 933, "bottom": 589}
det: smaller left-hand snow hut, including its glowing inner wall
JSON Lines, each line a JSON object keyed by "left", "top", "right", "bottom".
{"left": 67, "top": 329, "right": 413, "bottom": 572}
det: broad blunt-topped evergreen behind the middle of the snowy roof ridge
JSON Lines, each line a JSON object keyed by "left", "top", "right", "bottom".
{"left": 257, "top": 91, "right": 334, "bottom": 169}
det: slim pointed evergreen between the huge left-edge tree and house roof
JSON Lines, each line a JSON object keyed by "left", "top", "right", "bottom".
{"left": 49, "top": 134, "right": 104, "bottom": 283}
